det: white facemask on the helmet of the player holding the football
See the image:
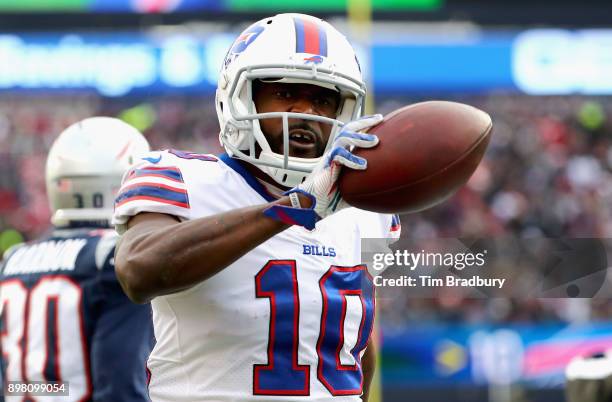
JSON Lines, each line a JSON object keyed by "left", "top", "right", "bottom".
{"left": 219, "top": 65, "right": 365, "bottom": 187}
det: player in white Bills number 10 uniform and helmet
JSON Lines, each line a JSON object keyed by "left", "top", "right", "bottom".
{"left": 114, "top": 14, "right": 399, "bottom": 401}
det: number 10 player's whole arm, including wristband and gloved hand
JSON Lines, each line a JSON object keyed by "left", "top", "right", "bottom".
{"left": 115, "top": 115, "right": 382, "bottom": 303}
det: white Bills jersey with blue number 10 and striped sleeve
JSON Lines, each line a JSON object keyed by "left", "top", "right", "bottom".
{"left": 114, "top": 150, "right": 399, "bottom": 402}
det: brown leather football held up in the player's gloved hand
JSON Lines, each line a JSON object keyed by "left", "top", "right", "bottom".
{"left": 338, "top": 101, "right": 492, "bottom": 213}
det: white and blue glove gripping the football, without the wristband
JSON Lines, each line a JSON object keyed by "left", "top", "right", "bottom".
{"left": 297, "top": 114, "right": 383, "bottom": 219}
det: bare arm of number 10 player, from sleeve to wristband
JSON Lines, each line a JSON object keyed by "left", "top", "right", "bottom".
{"left": 115, "top": 194, "right": 312, "bottom": 303}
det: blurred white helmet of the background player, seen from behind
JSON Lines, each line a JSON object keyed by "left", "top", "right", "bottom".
{"left": 46, "top": 117, "right": 149, "bottom": 226}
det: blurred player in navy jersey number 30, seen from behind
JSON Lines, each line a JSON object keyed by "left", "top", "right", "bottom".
{"left": 0, "top": 117, "right": 153, "bottom": 401}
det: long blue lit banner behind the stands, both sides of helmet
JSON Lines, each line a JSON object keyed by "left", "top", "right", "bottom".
{"left": 0, "top": 29, "right": 612, "bottom": 96}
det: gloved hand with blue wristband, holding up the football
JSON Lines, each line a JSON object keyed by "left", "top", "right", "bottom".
{"left": 264, "top": 114, "right": 383, "bottom": 230}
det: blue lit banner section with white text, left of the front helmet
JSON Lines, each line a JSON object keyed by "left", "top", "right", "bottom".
{"left": 0, "top": 33, "right": 231, "bottom": 96}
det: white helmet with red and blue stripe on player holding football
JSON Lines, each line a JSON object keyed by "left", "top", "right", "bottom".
{"left": 215, "top": 14, "right": 366, "bottom": 187}
